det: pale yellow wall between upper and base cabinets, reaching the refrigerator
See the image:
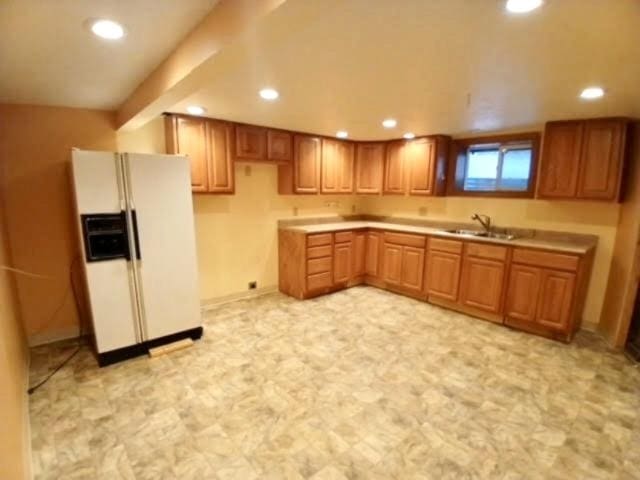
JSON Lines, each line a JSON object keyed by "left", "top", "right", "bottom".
{"left": 118, "top": 118, "right": 620, "bottom": 328}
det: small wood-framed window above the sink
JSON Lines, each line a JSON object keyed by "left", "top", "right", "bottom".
{"left": 448, "top": 133, "right": 539, "bottom": 197}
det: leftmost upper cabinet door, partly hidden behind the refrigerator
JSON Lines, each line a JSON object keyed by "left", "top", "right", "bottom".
{"left": 167, "top": 117, "right": 209, "bottom": 192}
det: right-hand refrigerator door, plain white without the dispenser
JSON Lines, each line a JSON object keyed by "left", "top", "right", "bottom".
{"left": 123, "top": 154, "right": 201, "bottom": 340}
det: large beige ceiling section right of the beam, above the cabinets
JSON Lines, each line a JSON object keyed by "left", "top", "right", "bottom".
{"left": 171, "top": 0, "right": 640, "bottom": 139}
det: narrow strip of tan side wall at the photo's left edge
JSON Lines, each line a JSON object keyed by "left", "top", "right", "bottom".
{"left": 0, "top": 195, "right": 30, "bottom": 480}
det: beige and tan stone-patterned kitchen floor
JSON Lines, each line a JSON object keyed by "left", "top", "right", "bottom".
{"left": 31, "top": 287, "right": 640, "bottom": 480}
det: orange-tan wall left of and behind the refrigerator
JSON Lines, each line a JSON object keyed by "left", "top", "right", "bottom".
{"left": 0, "top": 105, "right": 116, "bottom": 342}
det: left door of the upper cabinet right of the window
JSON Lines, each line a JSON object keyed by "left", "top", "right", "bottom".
{"left": 538, "top": 122, "right": 584, "bottom": 198}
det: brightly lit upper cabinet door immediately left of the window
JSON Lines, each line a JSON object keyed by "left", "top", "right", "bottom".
{"left": 405, "top": 138, "right": 436, "bottom": 195}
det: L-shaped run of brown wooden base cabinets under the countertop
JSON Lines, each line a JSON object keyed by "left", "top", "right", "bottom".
{"left": 278, "top": 228, "right": 594, "bottom": 342}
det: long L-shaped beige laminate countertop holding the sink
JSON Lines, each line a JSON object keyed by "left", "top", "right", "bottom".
{"left": 280, "top": 220, "right": 597, "bottom": 255}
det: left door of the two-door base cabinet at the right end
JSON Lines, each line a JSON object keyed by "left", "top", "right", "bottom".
{"left": 505, "top": 264, "right": 542, "bottom": 323}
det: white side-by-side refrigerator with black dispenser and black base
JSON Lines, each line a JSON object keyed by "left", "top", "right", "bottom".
{"left": 72, "top": 149, "right": 202, "bottom": 366}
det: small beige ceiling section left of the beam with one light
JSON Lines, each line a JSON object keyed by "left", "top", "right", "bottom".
{"left": 0, "top": 0, "right": 218, "bottom": 109}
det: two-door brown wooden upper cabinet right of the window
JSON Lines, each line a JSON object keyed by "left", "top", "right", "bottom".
{"left": 538, "top": 118, "right": 628, "bottom": 201}
